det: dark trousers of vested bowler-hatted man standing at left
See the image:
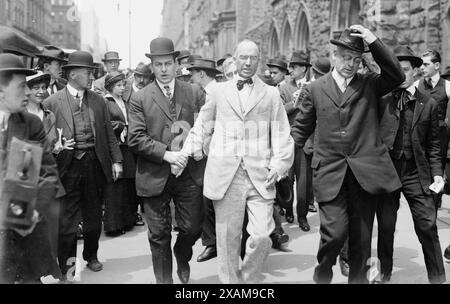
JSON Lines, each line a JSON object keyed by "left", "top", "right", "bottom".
{"left": 58, "top": 150, "right": 105, "bottom": 275}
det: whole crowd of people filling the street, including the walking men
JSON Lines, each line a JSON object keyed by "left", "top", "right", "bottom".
{"left": 0, "top": 25, "right": 450, "bottom": 284}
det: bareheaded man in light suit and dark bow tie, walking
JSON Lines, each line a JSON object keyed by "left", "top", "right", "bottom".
{"left": 183, "top": 40, "right": 294, "bottom": 284}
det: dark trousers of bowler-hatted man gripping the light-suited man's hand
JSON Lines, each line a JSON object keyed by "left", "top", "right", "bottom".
{"left": 142, "top": 170, "right": 204, "bottom": 284}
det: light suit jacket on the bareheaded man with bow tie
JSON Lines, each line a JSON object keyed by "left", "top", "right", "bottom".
{"left": 184, "top": 77, "right": 294, "bottom": 200}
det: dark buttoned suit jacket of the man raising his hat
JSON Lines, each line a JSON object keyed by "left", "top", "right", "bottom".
{"left": 292, "top": 40, "right": 405, "bottom": 202}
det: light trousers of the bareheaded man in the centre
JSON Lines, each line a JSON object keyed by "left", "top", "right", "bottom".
{"left": 213, "top": 166, "right": 275, "bottom": 284}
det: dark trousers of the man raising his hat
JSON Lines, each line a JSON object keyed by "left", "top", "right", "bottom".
{"left": 314, "top": 168, "right": 377, "bottom": 283}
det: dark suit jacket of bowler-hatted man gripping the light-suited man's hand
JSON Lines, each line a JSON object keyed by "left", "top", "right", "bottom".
{"left": 128, "top": 80, "right": 205, "bottom": 197}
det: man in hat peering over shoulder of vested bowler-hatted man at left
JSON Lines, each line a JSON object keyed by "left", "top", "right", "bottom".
{"left": 36, "top": 45, "right": 67, "bottom": 98}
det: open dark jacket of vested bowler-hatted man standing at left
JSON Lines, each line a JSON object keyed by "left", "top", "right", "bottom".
{"left": 44, "top": 88, "right": 122, "bottom": 182}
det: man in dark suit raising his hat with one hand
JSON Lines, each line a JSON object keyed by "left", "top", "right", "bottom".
{"left": 292, "top": 25, "right": 405, "bottom": 283}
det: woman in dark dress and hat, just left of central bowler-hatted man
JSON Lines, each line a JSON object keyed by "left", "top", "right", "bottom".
{"left": 104, "top": 72, "right": 138, "bottom": 237}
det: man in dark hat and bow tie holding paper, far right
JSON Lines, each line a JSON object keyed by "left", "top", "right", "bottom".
{"left": 377, "top": 46, "right": 445, "bottom": 283}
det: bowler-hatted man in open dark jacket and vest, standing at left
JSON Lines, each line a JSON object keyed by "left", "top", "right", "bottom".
{"left": 45, "top": 51, "right": 122, "bottom": 275}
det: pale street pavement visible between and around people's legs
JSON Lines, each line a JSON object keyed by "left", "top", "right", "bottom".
{"left": 66, "top": 197, "right": 450, "bottom": 284}
